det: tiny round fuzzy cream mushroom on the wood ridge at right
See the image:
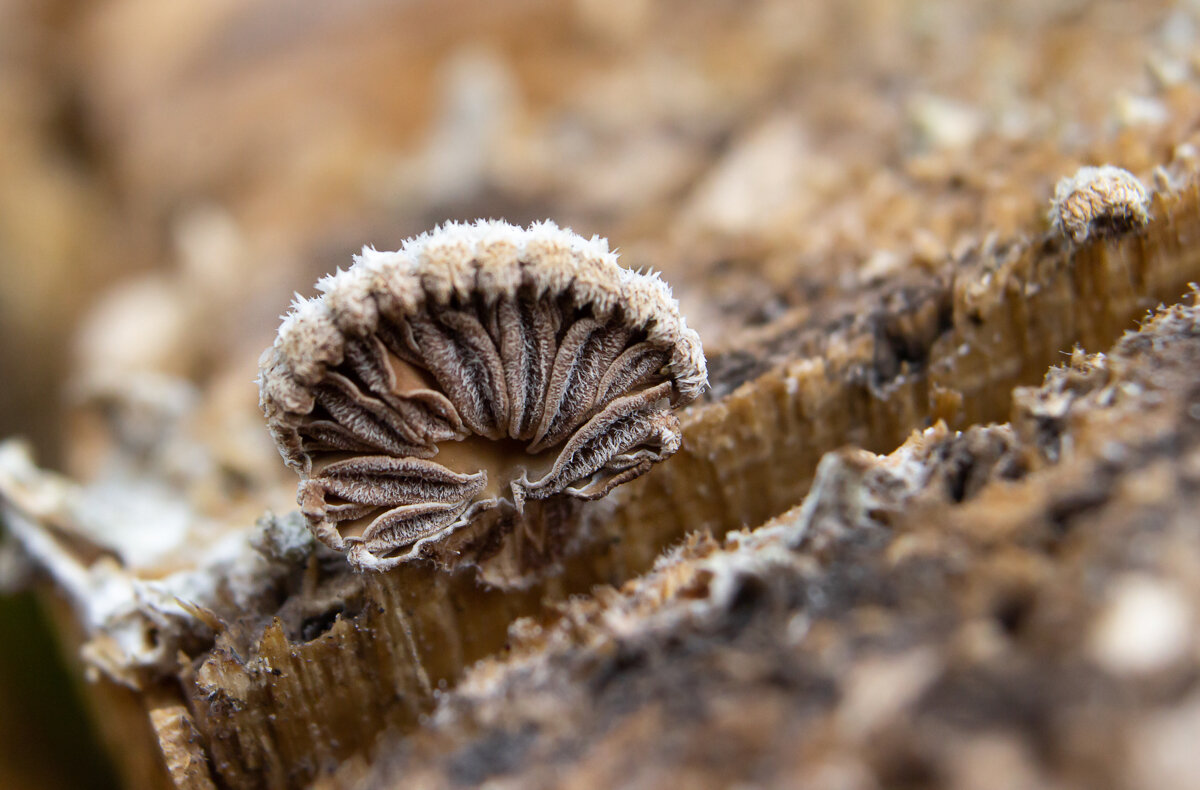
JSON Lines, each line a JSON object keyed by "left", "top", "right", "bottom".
{"left": 1050, "top": 164, "right": 1150, "bottom": 245}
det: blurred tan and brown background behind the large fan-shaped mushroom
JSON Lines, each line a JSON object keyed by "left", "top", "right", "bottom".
{"left": 0, "top": 0, "right": 1200, "bottom": 788}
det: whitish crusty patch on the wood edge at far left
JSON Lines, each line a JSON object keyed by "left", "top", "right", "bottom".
{"left": 0, "top": 441, "right": 313, "bottom": 688}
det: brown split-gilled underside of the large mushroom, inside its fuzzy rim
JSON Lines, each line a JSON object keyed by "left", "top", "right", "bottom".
{"left": 295, "top": 297, "right": 679, "bottom": 565}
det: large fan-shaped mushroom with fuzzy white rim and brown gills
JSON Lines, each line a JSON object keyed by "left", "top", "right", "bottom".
{"left": 259, "top": 221, "right": 707, "bottom": 570}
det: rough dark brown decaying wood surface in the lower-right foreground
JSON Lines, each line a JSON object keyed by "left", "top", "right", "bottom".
{"left": 318, "top": 294, "right": 1200, "bottom": 789}
